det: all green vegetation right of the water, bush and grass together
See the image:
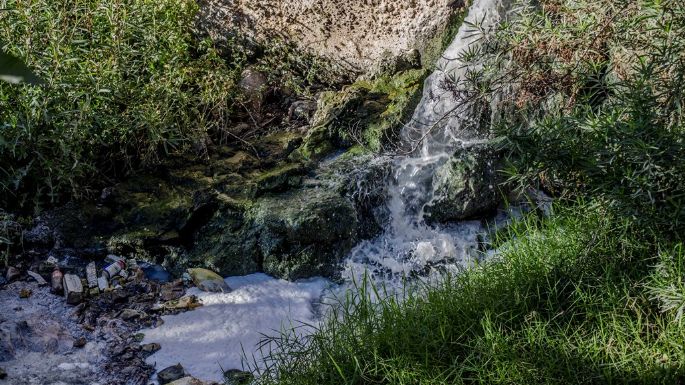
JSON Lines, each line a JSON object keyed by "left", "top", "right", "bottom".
{"left": 254, "top": 0, "right": 685, "bottom": 385}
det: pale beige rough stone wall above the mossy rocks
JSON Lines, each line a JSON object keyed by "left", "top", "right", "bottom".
{"left": 200, "top": 0, "right": 464, "bottom": 75}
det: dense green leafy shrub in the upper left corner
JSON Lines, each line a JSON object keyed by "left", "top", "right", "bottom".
{"left": 0, "top": 0, "right": 244, "bottom": 208}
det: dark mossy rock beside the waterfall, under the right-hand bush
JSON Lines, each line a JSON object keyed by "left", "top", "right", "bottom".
{"left": 426, "top": 144, "right": 500, "bottom": 222}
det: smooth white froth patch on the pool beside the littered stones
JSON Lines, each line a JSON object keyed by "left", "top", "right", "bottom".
{"left": 143, "top": 274, "right": 331, "bottom": 381}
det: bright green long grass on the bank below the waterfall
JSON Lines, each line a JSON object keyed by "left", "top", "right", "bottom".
{"left": 254, "top": 205, "right": 685, "bottom": 385}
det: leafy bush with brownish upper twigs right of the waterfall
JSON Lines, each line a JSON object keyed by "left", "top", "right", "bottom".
{"left": 457, "top": 0, "right": 685, "bottom": 236}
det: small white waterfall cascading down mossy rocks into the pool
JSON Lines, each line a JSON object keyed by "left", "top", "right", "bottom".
{"left": 343, "top": 0, "right": 509, "bottom": 282}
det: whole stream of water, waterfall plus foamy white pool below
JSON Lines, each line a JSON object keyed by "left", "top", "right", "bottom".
{"left": 145, "top": 0, "right": 507, "bottom": 381}
